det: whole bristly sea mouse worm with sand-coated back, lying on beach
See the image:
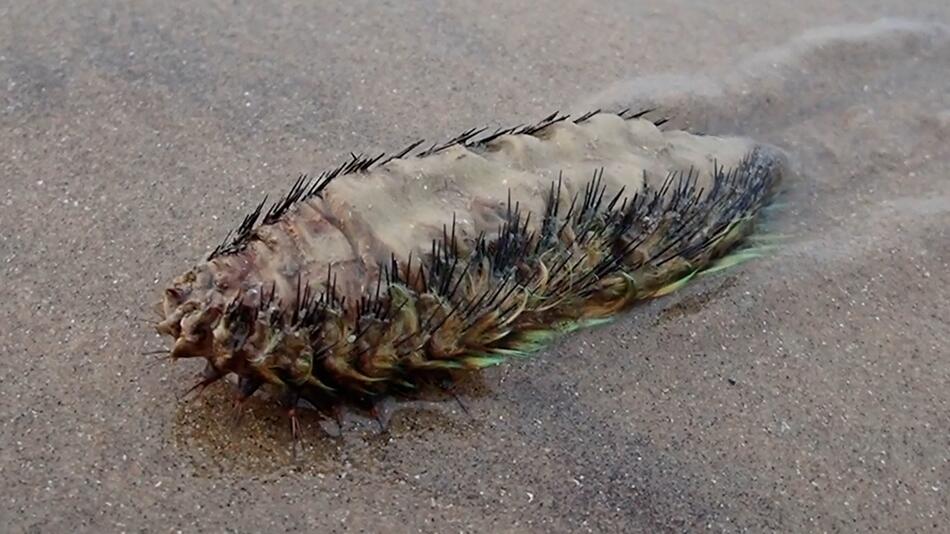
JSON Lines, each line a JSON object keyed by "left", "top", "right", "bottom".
{"left": 157, "top": 112, "right": 785, "bottom": 430}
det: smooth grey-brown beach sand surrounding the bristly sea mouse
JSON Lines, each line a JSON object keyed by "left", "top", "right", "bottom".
{"left": 0, "top": 0, "right": 950, "bottom": 532}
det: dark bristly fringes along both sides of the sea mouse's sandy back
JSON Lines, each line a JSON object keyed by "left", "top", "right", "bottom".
{"left": 154, "top": 111, "right": 780, "bottom": 440}
